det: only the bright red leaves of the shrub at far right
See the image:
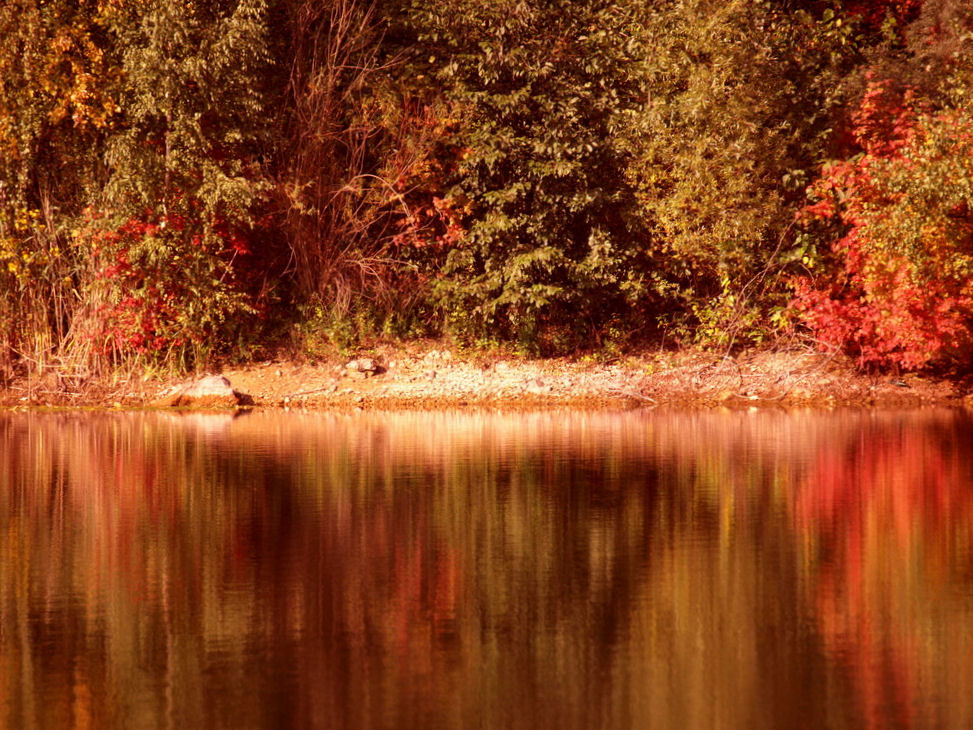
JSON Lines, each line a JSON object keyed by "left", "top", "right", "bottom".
{"left": 793, "top": 79, "right": 973, "bottom": 370}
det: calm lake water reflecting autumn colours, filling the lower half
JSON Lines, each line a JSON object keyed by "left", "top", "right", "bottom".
{"left": 0, "top": 411, "right": 973, "bottom": 730}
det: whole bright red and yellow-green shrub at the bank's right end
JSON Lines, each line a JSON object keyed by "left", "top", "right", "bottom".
{"left": 794, "top": 78, "right": 973, "bottom": 370}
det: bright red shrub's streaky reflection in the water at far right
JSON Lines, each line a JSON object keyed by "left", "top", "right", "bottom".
{"left": 793, "top": 420, "right": 973, "bottom": 728}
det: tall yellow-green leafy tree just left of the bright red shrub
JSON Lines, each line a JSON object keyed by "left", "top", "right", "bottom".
{"left": 627, "top": 0, "right": 854, "bottom": 345}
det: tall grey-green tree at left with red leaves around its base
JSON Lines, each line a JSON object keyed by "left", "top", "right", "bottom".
{"left": 85, "top": 0, "right": 272, "bottom": 363}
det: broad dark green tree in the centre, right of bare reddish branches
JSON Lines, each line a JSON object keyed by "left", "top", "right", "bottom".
{"left": 394, "top": 0, "right": 653, "bottom": 352}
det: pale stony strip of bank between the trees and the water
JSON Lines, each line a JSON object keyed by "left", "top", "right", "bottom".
{"left": 0, "top": 343, "right": 973, "bottom": 410}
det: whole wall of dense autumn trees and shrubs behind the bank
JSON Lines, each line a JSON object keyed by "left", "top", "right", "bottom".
{"left": 0, "top": 0, "right": 973, "bottom": 376}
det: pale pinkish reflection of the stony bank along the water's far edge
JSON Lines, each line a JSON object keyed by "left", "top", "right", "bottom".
{"left": 180, "top": 409, "right": 968, "bottom": 470}
